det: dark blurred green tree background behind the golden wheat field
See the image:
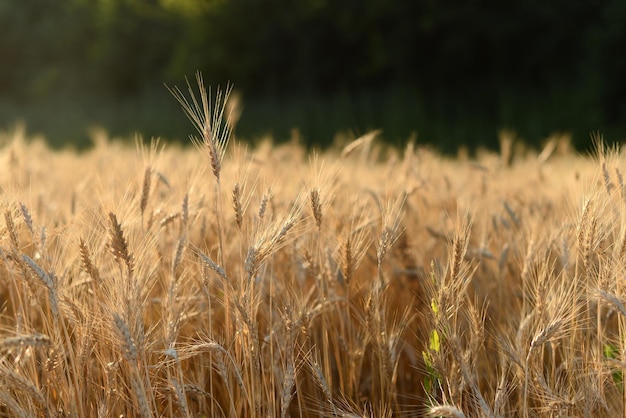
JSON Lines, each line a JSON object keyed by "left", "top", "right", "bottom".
{"left": 0, "top": 0, "right": 626, "bottom": 152}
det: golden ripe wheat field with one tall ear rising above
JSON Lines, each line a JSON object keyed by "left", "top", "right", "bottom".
{"left": 0, "top": 82, "right": 626, "bottom": 417}
